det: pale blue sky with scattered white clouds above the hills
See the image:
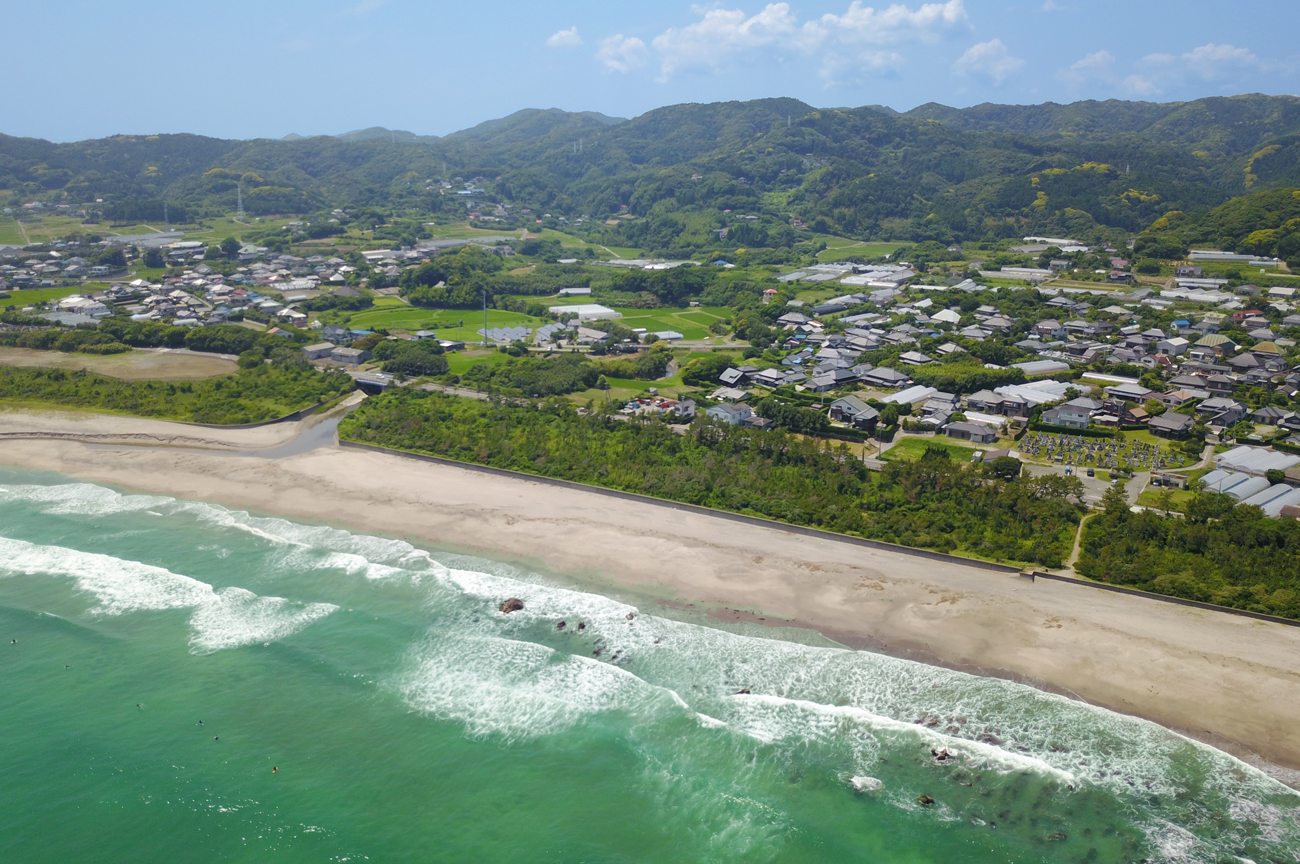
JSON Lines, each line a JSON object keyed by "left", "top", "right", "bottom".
{"left": 10, "top": 0, "right": 1300, "bottom": 142}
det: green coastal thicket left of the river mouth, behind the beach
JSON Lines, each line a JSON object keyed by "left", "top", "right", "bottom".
{"left": 0, "top": 362, "right": 354, "bottom": 426}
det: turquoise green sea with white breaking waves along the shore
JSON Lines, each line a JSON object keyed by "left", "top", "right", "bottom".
{"left": 0, "top": 472, "right": 1300, "bottom": 864}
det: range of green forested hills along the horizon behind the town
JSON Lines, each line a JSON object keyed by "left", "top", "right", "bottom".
{"left": 0, "top": 95, "right": 1300, "bottom": 248}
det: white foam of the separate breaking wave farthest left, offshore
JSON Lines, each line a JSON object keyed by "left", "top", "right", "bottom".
{"left": 0, "top": 537, "right": 338, "bottom": 654}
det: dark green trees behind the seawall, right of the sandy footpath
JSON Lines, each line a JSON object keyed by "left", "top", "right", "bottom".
{"left": 1078, "top": 490, "right": 1300, "bottom": 618}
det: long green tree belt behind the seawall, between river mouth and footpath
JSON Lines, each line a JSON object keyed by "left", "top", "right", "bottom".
{"left": 339, "top": 390, "right": 1083, "bottom": 566}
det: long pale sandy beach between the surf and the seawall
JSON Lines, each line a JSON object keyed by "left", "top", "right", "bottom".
{"left": 0, "top": 412, "right": 1300, "bottom": 785}
